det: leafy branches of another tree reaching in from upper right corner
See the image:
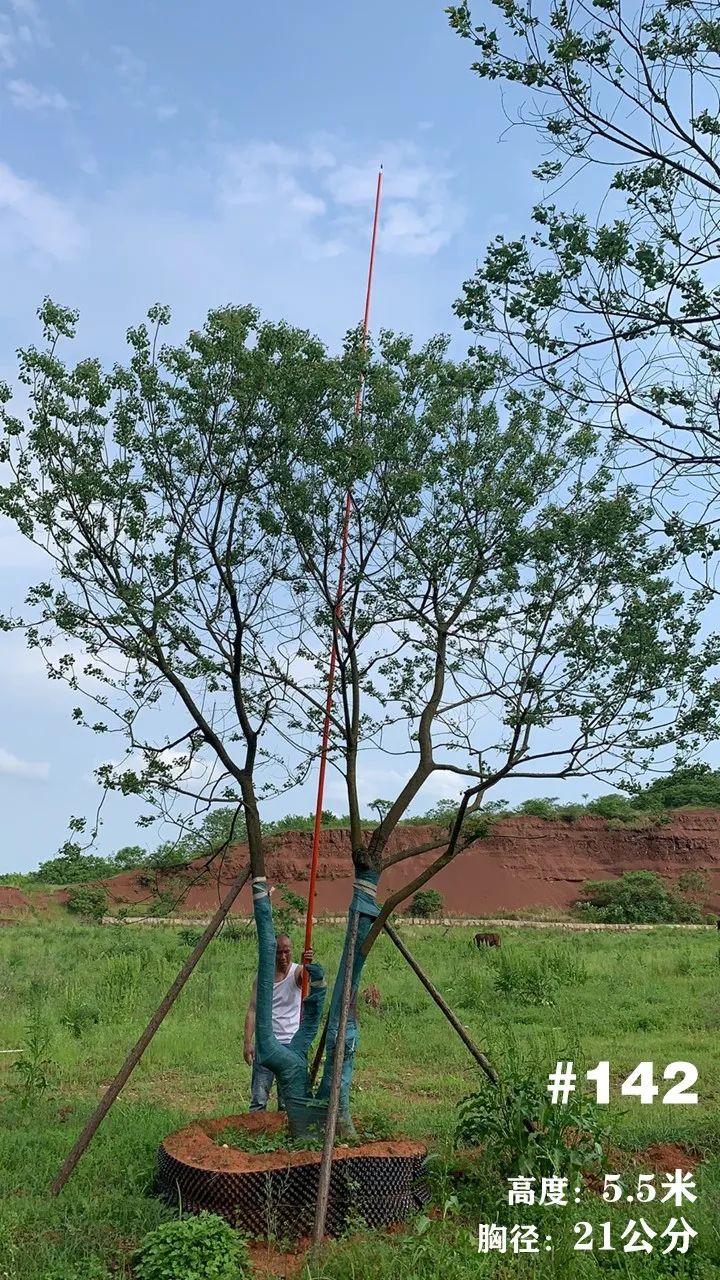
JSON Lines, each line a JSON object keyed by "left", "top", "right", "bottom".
{"left": 447, "top": 0, "right": 720, "bottom": 478}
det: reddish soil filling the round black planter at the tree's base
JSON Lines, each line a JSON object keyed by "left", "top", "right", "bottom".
{"left": 163, "top": 1111, "right": 428, "bottom": 1174}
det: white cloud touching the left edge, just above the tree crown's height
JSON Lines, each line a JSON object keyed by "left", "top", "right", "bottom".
{"left": 0, "top": 160, "right": 81, "bottom": 261}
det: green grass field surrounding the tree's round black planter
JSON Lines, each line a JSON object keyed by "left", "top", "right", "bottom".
{"left": 0, "top": 924, "right": 720, "bottom": 1280}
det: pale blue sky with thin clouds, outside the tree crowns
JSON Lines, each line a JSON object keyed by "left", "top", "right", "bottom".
{"left": 0, "top": 0, "right": 691, "bottom": 870}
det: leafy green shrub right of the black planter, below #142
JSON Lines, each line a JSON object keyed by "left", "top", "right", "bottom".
{"left": 455, "top": 1078, "right": 606, "bottom": 1178}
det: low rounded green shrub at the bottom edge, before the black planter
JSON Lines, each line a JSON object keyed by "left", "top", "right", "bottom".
{"left": 132, "top": 1212, "right": 250, "bottom": 1280}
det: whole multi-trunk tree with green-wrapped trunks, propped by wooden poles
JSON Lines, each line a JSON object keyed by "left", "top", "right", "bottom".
{"left": 0, "top": 302, "right": 715, "bottom": 1123}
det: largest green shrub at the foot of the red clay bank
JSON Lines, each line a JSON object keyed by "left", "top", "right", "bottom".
{"left": 578, "top": 872, "right": 702, "bottom": 924}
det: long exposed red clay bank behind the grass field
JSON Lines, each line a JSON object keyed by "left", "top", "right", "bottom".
{"left": 67, "top": 810, "right": 720, "bottom": 915}
